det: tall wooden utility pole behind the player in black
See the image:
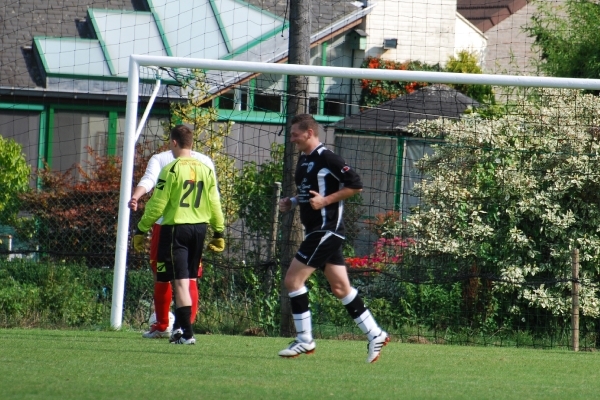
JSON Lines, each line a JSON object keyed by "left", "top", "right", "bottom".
{"left": 280, "top": 0, "right": 311, "bottom": 336}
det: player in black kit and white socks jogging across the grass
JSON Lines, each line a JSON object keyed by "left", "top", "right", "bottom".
{"left": 279, "top": 114, "right": 389, "bottom": 363}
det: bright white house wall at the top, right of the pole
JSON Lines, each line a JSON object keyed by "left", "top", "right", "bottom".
{"left": 365, "top": 0, "right": 456, "bottom": 64}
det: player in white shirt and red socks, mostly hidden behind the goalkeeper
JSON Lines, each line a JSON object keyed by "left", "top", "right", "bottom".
{"left": 128, "top": 126, "right": 222, "bottom": 339}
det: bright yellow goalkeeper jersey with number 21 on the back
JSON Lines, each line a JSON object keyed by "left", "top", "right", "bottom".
{"left": 138, "top": 157, "right": 225, "bottom": 232}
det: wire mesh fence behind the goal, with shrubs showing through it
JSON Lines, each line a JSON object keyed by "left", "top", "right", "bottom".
{"left": 0, "top": 86, "right": 600, "bottom": 348}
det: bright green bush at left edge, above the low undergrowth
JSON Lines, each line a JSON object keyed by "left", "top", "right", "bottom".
{"left": 0, "top": 136, "right": 31, "bottom": 225}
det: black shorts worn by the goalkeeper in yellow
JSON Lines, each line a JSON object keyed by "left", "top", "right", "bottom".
{"left": 156, "top": 224, "right": 206, "bottom": 282}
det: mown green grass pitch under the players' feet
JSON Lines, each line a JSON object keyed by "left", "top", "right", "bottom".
{"left": 0, "top": 329, "right": 600, "bottom": 400}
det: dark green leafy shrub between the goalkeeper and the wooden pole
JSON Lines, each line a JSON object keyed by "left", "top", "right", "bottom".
{"left": 233, "top": 143, "right": 284, "bottom": 238}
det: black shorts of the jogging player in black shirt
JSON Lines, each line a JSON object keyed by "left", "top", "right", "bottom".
{"left": 295, "top": 231, "right": 346, "bottom": 269}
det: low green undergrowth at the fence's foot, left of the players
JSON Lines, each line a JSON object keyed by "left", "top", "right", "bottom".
{"left": 0, "top": 260, "right": 153, "bottom": 327}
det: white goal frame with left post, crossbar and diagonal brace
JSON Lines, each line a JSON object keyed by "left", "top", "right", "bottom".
{"left": 110, "top": 54, "right": 600, "bottom": 329}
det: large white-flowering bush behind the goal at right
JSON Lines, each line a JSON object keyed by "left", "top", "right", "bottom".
{"left": 407, "top": 89, "right": 600, "bottom": 317}
